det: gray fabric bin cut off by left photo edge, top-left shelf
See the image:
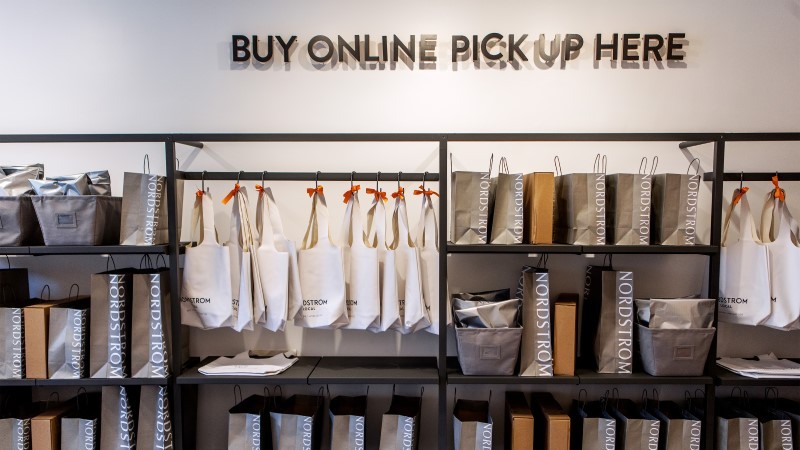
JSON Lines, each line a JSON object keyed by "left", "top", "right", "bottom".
{"left": 0, "top": 195, "right": 42, "bottom": 246}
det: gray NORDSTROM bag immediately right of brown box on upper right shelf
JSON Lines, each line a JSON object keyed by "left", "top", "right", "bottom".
{"left": 553, "top": 155, "right": 608, "bottom": 245}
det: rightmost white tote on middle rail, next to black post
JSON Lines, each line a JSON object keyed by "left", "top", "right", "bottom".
{"left": 414, "top": 186, "right": 452, "bottom": 334}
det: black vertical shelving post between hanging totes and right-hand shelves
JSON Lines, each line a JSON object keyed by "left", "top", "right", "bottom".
{"left": 438, "top": 136, "right": 450, "bottom": 449}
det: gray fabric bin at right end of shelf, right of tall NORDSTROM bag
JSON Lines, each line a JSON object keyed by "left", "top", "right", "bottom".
{"left": 637, "top": 324, "right": 716, "bottom": 376}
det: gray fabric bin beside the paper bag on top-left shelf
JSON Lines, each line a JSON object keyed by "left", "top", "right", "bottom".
{"left": 31, "top": 195, "right": 122, "bottom": 245}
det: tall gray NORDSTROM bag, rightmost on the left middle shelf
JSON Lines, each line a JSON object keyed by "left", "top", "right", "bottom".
{"left": 131, "top": 268, "right": 172, "bottom": 378}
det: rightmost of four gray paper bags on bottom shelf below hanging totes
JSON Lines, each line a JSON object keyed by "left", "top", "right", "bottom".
{"left": 378, "top": 394, "right": 422, "bottom": 450}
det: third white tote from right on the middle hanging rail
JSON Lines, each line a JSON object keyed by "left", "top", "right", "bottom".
{"left": 367, "top": 188, "right": 401, "bottom": 331}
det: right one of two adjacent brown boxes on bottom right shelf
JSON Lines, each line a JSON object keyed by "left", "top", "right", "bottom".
{"left": 531, "top": 392, "right": 570, "bottom": 450}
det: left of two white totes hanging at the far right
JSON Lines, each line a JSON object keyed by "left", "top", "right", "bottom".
{"left": 717, "top": 188, "right": 771, "bottom": 325}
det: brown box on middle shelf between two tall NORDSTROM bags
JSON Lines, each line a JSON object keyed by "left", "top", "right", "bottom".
{"left": 553, "top": 294, "right": 578, "bottom": 376}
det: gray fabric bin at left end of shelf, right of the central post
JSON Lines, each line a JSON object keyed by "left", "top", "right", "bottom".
{"left": 456, "top": 327, "right": 522, "bottom": 375}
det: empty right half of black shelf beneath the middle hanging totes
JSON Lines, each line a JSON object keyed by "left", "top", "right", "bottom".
{"left": 308, "top": 356, "right": 439, "bottom": 384}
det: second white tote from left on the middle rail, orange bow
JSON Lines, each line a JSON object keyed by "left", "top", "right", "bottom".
{"left": 227, "top": 183, "right": 253, "bottom": 331}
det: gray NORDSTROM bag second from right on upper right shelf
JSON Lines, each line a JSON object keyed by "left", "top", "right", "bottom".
{"left": 606, "top": 157, "right": 658, "bottom": 245}
